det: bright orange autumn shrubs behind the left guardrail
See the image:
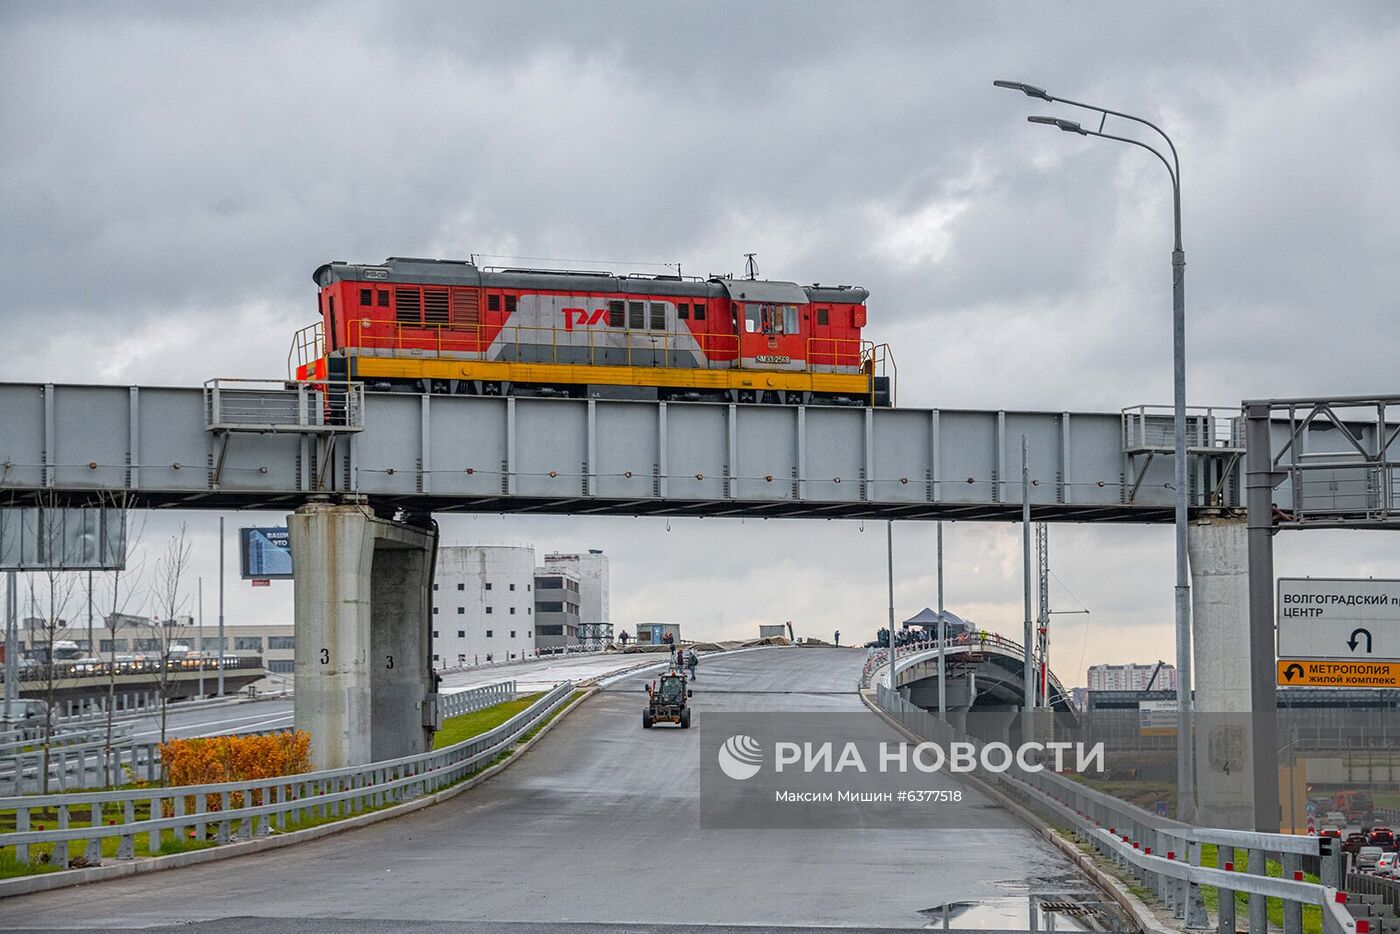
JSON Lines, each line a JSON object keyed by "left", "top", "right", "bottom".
{"left": 161, "top": 730, "right": 311, "bottom": 811}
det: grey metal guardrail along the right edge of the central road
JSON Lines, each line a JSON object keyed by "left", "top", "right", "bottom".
{"left": 876, "top": 685, "right": 1355, "bottom": 934}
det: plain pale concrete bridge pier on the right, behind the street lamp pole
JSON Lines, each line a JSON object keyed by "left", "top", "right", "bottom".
{"left": 1189, "top": 518, "right": 1254, "bottom": 830}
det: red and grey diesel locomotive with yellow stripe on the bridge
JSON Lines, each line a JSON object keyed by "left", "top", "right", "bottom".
{"left": 291, "top": 256, "right": 893, "bottom": 406}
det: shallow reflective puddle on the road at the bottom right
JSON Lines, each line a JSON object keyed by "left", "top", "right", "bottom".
{"left": 920, "top": 889, "right": 1137, "bottom": 934}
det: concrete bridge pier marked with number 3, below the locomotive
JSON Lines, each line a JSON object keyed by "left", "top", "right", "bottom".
{"left": 287, "top": 503, "right": 437, "bottom": 769}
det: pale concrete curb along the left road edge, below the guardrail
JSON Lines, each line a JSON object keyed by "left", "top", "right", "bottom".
{"left": 0, "top": 688, "right": 596, "bottom": 899}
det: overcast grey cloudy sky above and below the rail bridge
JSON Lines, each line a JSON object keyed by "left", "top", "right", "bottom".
{"left": 0, "top": 0, "right": 1400, "bottom": 683}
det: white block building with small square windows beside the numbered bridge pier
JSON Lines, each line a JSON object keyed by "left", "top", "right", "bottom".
{"left": 433, "top": 545, "right": 535, "bottom": 668}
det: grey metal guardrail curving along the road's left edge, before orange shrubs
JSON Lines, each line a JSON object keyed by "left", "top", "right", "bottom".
{"left": 0, "top": 682, "right": 574, "bottom": 868}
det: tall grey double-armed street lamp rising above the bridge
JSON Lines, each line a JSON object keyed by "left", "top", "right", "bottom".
{"left": 993, "top": 81, "right": 1196, "bottom": 821}
